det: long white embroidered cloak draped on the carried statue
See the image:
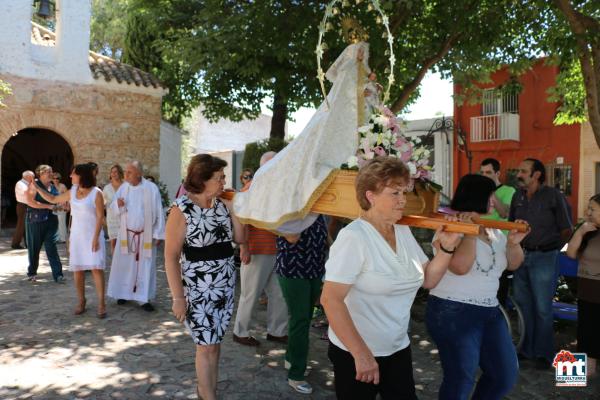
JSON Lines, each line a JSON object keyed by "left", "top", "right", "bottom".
{"left": 233, "top": 41, "right": 370, "bottom": 233}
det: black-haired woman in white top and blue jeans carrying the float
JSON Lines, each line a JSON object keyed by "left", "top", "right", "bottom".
{"left": 425, "top": 175, "right": 527, "bottom": 400}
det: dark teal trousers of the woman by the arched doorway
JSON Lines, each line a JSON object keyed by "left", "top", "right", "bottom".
{"left": 25, "top": 215, "right": 63, "bottom": 281}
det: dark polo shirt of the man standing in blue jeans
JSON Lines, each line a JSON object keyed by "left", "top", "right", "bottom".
{"left": 508, "top": 185, "right": 573, "bottom": 251}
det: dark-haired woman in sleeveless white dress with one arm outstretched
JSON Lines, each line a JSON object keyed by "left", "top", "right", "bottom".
{"left": 38, "top": 164, "right": 106, "bottom": 319}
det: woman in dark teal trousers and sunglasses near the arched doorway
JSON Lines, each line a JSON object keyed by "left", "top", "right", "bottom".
{"left": 25, "top": 164, "right": 65, "bottom": 283}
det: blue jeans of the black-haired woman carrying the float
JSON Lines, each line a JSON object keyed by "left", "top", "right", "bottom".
{"left": 425, "top": 296, "right": 519, "bottom": 400}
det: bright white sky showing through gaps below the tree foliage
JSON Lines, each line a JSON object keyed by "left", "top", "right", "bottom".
{"left": 280, "top": 73, "right": 453, "bottom": 136}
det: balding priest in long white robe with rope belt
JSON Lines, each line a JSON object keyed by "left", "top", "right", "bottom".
{"left": 107, "top": 161, "right": 165, "bottom": 311}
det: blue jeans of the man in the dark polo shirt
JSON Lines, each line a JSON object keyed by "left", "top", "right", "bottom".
{"left": 513, "top": 250, "right": 559, "bottom": 361}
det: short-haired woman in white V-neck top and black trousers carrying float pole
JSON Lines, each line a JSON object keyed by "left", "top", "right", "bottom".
{"left": 321, "top": 157, "right": 460, "bottom": 400}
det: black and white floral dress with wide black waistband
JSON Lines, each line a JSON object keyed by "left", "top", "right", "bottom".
{"left": 175, "top": 195, "right": 235, "bottom": 345}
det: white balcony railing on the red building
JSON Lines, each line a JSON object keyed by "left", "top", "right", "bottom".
{"left": 471, "top": 113, "right": 519, "bottom": 143}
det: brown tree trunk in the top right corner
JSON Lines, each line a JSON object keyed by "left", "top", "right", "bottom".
{"left": 554, "top": 0, "right": 600, "bottom": 148}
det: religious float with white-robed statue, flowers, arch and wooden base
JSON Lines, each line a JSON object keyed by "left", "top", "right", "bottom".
{"left": 229, "top": 0, "right": 528, "bottom": 235}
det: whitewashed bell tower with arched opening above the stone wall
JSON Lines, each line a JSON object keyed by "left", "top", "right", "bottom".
{"left": 0, "top": 0, "right": 93, "bottom": 83}
